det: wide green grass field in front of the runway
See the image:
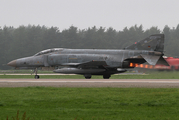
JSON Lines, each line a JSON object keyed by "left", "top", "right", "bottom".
{"left": 0, "top": 87, "right": 179, "bottom": 120}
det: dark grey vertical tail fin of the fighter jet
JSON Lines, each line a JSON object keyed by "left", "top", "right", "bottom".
{"left": 124, "top": 34, "right": 164, "bottom": 53}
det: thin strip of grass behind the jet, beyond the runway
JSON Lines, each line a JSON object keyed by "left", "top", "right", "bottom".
{"left": 0, "top": 71, "right": 179, "bottom": 79}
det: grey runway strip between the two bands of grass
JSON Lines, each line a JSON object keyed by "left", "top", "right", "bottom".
{"left": 0, "top": 79, "right": 179, "bottom": 88}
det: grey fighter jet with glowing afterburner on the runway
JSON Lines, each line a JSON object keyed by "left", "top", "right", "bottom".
{"left": 8, "top": 34, "right": 168, "bottom": 79}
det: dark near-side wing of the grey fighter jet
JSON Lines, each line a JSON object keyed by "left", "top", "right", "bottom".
{"left": 62, "top": 61, "right": 107, "bottom": 69}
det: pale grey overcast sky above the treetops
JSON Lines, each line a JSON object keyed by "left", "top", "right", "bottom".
{"left": 0, "top": 0, "right": 179, "bottom": 30}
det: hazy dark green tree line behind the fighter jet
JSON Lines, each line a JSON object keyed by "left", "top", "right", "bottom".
{"left": 0, "top": 25, "right": 179, "bottom": 69}
